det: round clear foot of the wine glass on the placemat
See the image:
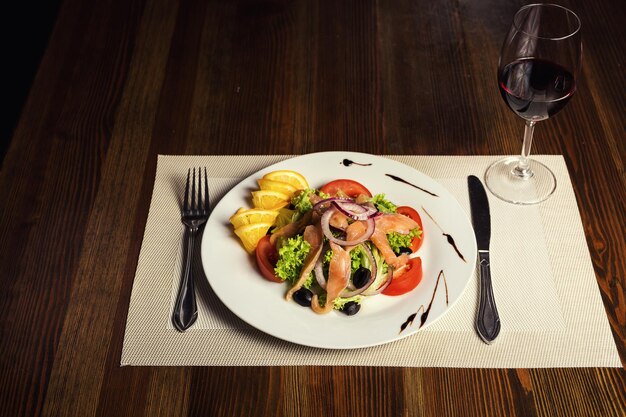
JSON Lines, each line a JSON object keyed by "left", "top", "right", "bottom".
{"left": 485, "top": 156, "right": 556, "bottom": 205}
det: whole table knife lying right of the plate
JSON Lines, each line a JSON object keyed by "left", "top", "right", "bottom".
{"left": 467, "top": 175, "right": 500, "bottom": 344}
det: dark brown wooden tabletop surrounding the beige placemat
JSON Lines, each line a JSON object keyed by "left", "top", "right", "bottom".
{"left": 0, "top": 0, "right": 626, "bottom": 417}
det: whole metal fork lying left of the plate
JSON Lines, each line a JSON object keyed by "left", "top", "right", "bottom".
{"left": 173, "top": 167, "right": 209, "bottom": 332}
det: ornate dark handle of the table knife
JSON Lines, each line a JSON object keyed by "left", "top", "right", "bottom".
{"left": 476, "top": 251, "right": 500, "bottom": 344}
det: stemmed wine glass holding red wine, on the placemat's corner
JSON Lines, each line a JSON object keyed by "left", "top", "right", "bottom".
{"left": 485, "top": 4, "right": 582, "bottom": 204}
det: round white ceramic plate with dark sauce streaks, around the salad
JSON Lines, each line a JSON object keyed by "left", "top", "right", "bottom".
{"left": 202, "top": 152, "right": 476, "bottom": 349}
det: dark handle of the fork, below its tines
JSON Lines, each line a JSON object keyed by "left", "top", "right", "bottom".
{"left": 173, "top": 227, "right": 198, "bottom": 332}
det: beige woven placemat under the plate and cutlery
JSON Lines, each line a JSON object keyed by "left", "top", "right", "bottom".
{"left": 121, "top": 155, "right": 622, "bottom": 368}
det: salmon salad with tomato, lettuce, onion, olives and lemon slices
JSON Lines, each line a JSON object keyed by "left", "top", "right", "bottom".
{"left": 230, "top": 170, "right": 424, "bottom": 316}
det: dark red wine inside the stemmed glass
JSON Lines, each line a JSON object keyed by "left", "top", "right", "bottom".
{"left": 498, "top": 58, "right": 576, "bottom": 121}
